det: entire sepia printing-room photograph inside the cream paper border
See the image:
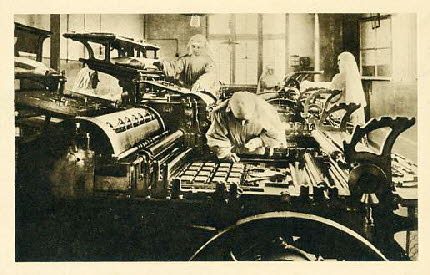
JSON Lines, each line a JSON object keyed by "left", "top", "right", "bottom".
{"left": 10, "top": 10, "right": 425, "bottom": 266}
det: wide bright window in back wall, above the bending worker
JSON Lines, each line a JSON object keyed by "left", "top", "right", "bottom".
{"left": 208, "top": 14, "right": 285, "bottom": 85}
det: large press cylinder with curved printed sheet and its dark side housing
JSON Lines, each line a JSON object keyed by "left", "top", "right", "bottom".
{"left": 51, "top": 107, "right": 188, "bottom": 198}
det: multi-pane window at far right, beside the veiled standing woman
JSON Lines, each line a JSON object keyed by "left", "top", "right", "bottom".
{"left": 360, "top": 16, "right": 392, "bottom": 79}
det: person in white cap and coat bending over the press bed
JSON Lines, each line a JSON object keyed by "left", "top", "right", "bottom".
{"left": 206, "top": 92, "right": 286, "bottom": 162}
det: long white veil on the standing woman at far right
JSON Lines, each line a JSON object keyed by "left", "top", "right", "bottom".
{"left": 338, "top": 52, "right": 366, "bottom": 107}
